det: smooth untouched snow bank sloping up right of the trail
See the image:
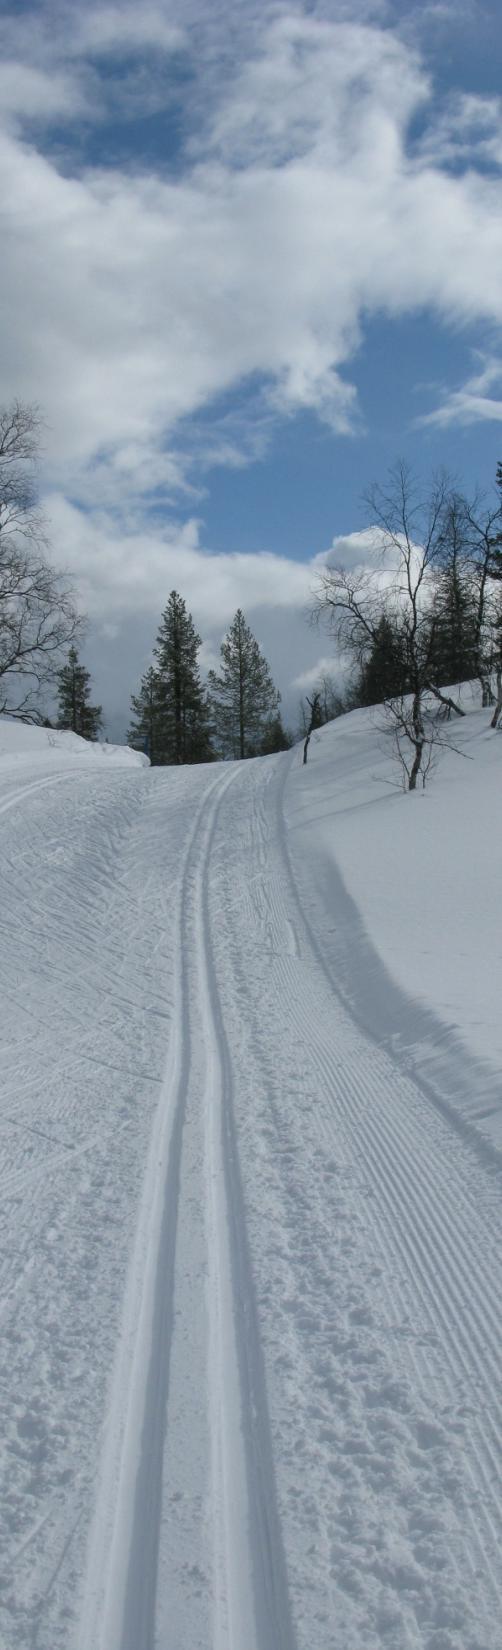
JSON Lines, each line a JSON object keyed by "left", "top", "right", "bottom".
{"left": 286, "top": 688, "right": 502, "bottom": 1143}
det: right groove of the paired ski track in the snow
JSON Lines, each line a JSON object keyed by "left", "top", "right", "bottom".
{"left": 197, "top": 775, "right": 294, "bottom": 1650}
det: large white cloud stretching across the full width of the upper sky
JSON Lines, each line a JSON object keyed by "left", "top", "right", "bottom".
{"left": 0, "top": 5, "right": 502, "bottom": 502}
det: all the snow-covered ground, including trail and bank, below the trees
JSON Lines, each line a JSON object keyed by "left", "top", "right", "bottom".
{"left": 0, "top": 713, "right": 502, "bottom": 1650}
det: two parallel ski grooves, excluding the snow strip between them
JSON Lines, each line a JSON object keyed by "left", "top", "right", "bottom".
{"left": 78, "top": 769, "right": 294, "bottom": 1650}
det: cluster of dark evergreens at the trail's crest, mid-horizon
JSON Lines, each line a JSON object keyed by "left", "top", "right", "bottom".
{"left": 127, "top": 591, "right": 289, "bottom": 767}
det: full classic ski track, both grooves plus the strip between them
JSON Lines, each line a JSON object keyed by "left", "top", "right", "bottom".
{"left": 79, "top": 771, "right": 294, "bottom": 1650}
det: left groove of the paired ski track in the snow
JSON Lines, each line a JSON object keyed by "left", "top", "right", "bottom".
{"left": 78, "top": 777, "right": 228, "bottom": 1650}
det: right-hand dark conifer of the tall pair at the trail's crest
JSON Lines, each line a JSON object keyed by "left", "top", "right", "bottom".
{"left": 208, "top": 609, "right": 281, "bottom": 757}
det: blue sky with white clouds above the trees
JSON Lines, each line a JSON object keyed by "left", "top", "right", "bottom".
{"left": 0, "top": 0, "right": 502, "bottom": 738}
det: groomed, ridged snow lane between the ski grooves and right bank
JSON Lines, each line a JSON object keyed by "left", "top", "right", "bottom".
{"left": 203, "top": 764, "right": 502, "bottom": 1650}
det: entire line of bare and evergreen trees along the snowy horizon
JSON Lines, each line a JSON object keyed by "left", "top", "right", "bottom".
{"left": 0, "top": 403, "right": 502, "bottom": 789}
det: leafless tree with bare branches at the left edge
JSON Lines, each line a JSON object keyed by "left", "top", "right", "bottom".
{"left": 0, "top": 401, "right": 83, "bottom": 721}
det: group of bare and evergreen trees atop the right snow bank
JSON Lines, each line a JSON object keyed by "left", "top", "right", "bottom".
{"left": 317, "top": 464, "right": 502, "bottom": 790}
